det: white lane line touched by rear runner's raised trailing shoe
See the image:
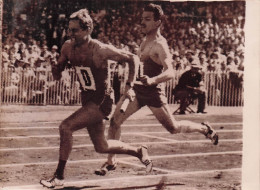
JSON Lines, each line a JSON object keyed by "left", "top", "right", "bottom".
{"left": 0, "top": 139, "right": 243, "bottom": 152}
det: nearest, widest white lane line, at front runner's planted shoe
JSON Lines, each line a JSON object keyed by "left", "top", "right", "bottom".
{"left": 3, "top": 168, "right": 242, "bottom": 190}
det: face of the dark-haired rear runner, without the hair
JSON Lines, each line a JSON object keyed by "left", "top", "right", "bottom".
{"left": 141, "top": 11, "right": 161, "bottom": 34}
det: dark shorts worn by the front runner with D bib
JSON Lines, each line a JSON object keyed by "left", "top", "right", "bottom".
{"left": 81, "top": 91, "right": 113, "bottom": 117}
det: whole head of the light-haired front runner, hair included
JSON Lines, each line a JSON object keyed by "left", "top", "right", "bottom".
{"left": 69, "top": 9, "right": 93, "bottom": 40}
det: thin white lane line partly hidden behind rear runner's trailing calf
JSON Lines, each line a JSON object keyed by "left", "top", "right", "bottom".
{"left": 0, "top": 122, "right": 243, "bottom": 130}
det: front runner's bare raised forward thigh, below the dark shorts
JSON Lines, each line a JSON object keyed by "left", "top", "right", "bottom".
{"left": 64, "top": 102, "right": 104, "bottom": 131}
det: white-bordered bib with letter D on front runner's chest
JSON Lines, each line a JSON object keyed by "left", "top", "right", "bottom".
{"left": 75, "top": 67, "right": 96, "bottom": 90}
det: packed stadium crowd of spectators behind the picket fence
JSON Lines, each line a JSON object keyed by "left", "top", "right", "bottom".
{"left": 2, "top": 0, "right": 245, "bottom": 93}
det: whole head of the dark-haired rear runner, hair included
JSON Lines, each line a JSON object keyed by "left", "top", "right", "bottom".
{"left": 141, "top": 3, "right": 164, "bottom": 34}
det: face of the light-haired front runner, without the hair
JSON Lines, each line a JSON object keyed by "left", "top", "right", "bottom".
{"left": 69, "top": 20, "right": 88, "bottom": 42}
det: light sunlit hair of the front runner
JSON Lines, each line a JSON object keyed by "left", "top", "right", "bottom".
{"left": 70, "top": 9, "right": 93, "bottom": 32}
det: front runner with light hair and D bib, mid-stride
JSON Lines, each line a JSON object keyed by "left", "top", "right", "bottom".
{"left": 40, "top": 9, "right": 152, "bottom": 187}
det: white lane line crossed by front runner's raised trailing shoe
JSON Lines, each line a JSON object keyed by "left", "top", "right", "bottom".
{"left": 0, "top": 151, "right": 242, "bottom": 168}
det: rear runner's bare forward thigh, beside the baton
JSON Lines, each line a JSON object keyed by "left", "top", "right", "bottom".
{"left": 110, "top": 96, "right": 141, "bottom": 125}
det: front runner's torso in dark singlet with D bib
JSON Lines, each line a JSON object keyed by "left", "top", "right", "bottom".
{"left": 68, "top": 39, "right": 108, "bottom": 105}
